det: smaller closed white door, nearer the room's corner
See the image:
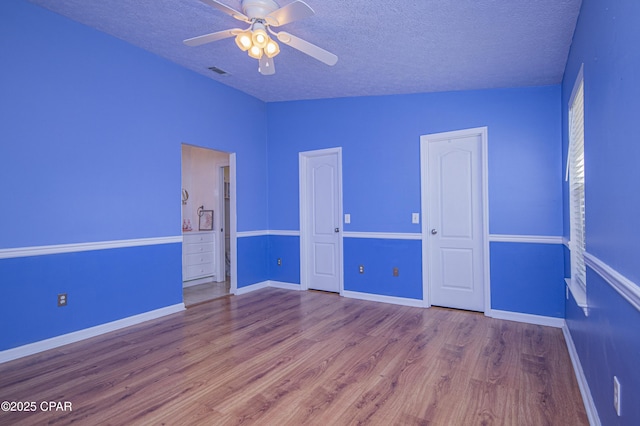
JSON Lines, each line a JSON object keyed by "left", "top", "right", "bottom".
{"left": 300, "top": 149, "right": 342, "bottom": 293}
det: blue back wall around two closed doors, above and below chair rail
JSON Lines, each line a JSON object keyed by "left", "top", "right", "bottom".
{"left": 267, "top": 86, "right": 564, "bottom": 310}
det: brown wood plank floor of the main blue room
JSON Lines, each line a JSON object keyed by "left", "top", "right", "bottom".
{"left": 0, "top": 288, "right": 588, "bottom": 426}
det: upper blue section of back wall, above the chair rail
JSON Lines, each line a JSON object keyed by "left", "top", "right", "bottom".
{"left": 267, "top": 86, "right": 563, "bottom": 235}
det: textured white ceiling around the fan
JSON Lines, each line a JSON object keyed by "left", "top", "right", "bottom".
{"left": 30, "top": 0, "right": 581, "bottom": 102}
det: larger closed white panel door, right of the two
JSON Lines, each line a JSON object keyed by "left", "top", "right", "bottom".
{"left": 422, "top": 129, "right": 487, "bottom": 311}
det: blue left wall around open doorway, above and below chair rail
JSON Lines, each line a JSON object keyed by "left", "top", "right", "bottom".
{"left": 0, "top": 0, "right": 267, "bottom": 349}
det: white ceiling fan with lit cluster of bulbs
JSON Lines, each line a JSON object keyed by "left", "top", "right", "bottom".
{"left": 184, "top": 0, "right": 338, "bottom": 75}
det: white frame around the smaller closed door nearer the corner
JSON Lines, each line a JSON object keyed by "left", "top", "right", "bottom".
{"left": 298, "top": 147, "right": 344, "bottom": 296}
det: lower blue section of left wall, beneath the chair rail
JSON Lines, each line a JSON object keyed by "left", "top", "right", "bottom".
{"left": 0, "top": 243, "right": 182, "bottom": 351}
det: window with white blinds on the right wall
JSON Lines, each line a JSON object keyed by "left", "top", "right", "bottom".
{"left": 567, "top": 69, "right": 587, "bottom": 296}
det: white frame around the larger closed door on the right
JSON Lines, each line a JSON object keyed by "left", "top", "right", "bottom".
{"left": 420, "top": 126, "right": 491, "bottom": 316}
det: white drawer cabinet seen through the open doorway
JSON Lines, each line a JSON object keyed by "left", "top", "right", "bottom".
{"left": 182, "top": 232, "right": 216, "bottom": 281}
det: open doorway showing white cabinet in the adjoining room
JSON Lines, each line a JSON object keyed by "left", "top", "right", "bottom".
{"left": 182, "top": 144, "right": 235, "bottom": 308}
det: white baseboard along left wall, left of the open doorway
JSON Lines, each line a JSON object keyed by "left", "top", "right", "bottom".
{"left": 0, "top": 303, "right": 184, "bottom": 364}
